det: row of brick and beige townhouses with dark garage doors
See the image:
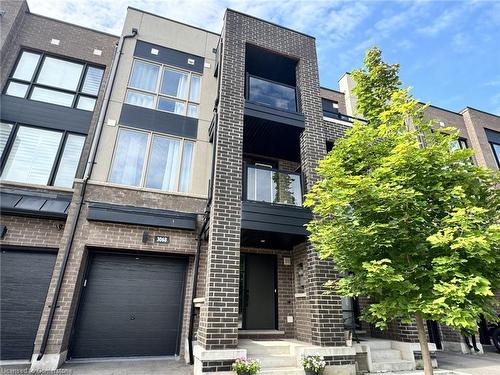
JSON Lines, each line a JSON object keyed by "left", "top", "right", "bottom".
{"left": 0, "top": 2, "right": 500, "bottom": 374}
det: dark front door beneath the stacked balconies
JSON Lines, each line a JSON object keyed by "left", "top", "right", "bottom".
{"left": 240, "top": 254, "right": 277, "bottom": 330}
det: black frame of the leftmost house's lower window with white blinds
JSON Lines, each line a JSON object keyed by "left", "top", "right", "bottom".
{"left": 0, "top": 121, "right": 87, "bottom": 189}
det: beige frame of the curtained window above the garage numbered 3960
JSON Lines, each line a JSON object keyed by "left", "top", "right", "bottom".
{"left": 106, "top": 125, "right": 196, "bottom": 194}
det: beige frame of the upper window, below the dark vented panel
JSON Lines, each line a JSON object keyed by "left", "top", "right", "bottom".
{"left": 123, "top": 56, "right": 203, "bottom": 119}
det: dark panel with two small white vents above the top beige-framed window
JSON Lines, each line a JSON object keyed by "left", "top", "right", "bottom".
{"left": 134, "top": 40, "right": 205, "bottom": 73}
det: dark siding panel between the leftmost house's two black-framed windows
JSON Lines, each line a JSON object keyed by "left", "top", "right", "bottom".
{"left": 1, "top": 95, "right": 93, "bottom": 134}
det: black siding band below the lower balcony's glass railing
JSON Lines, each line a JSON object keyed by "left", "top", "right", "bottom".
{"left": 241, "top": 201, "right": 312, "bottom": 236}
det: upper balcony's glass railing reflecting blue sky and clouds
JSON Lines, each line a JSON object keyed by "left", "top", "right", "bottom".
{"left": 247, "top": 75, "right": 297, "bottom": 112}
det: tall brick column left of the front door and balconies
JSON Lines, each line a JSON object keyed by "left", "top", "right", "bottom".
{"left": 198, "top": 19, "right": 245, "bottom": 350}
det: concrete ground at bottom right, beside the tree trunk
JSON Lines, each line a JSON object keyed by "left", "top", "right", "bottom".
{"left": 436, "top": 351, "right": 500, "bottom": 375}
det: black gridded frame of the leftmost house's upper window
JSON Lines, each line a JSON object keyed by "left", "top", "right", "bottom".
{"left": 2, "top": 47, "right": 106, "bottom": 112}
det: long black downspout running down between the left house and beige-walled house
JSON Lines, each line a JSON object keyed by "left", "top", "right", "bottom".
{"left": 36, "top": 28, "right": 137, "bottom": 361}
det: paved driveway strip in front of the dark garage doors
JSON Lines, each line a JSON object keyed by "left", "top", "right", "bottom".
{"left": 0, "top": 359, "right": 193, "bottom": 375}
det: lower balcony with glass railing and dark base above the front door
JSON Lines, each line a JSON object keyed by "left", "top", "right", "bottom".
{"left": 241, "top": 165, "right": 311, "bottom": 249}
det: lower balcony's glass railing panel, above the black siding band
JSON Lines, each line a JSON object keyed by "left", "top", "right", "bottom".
{"left": 245, "top": 165, "right": 302, "bottom": 206}
